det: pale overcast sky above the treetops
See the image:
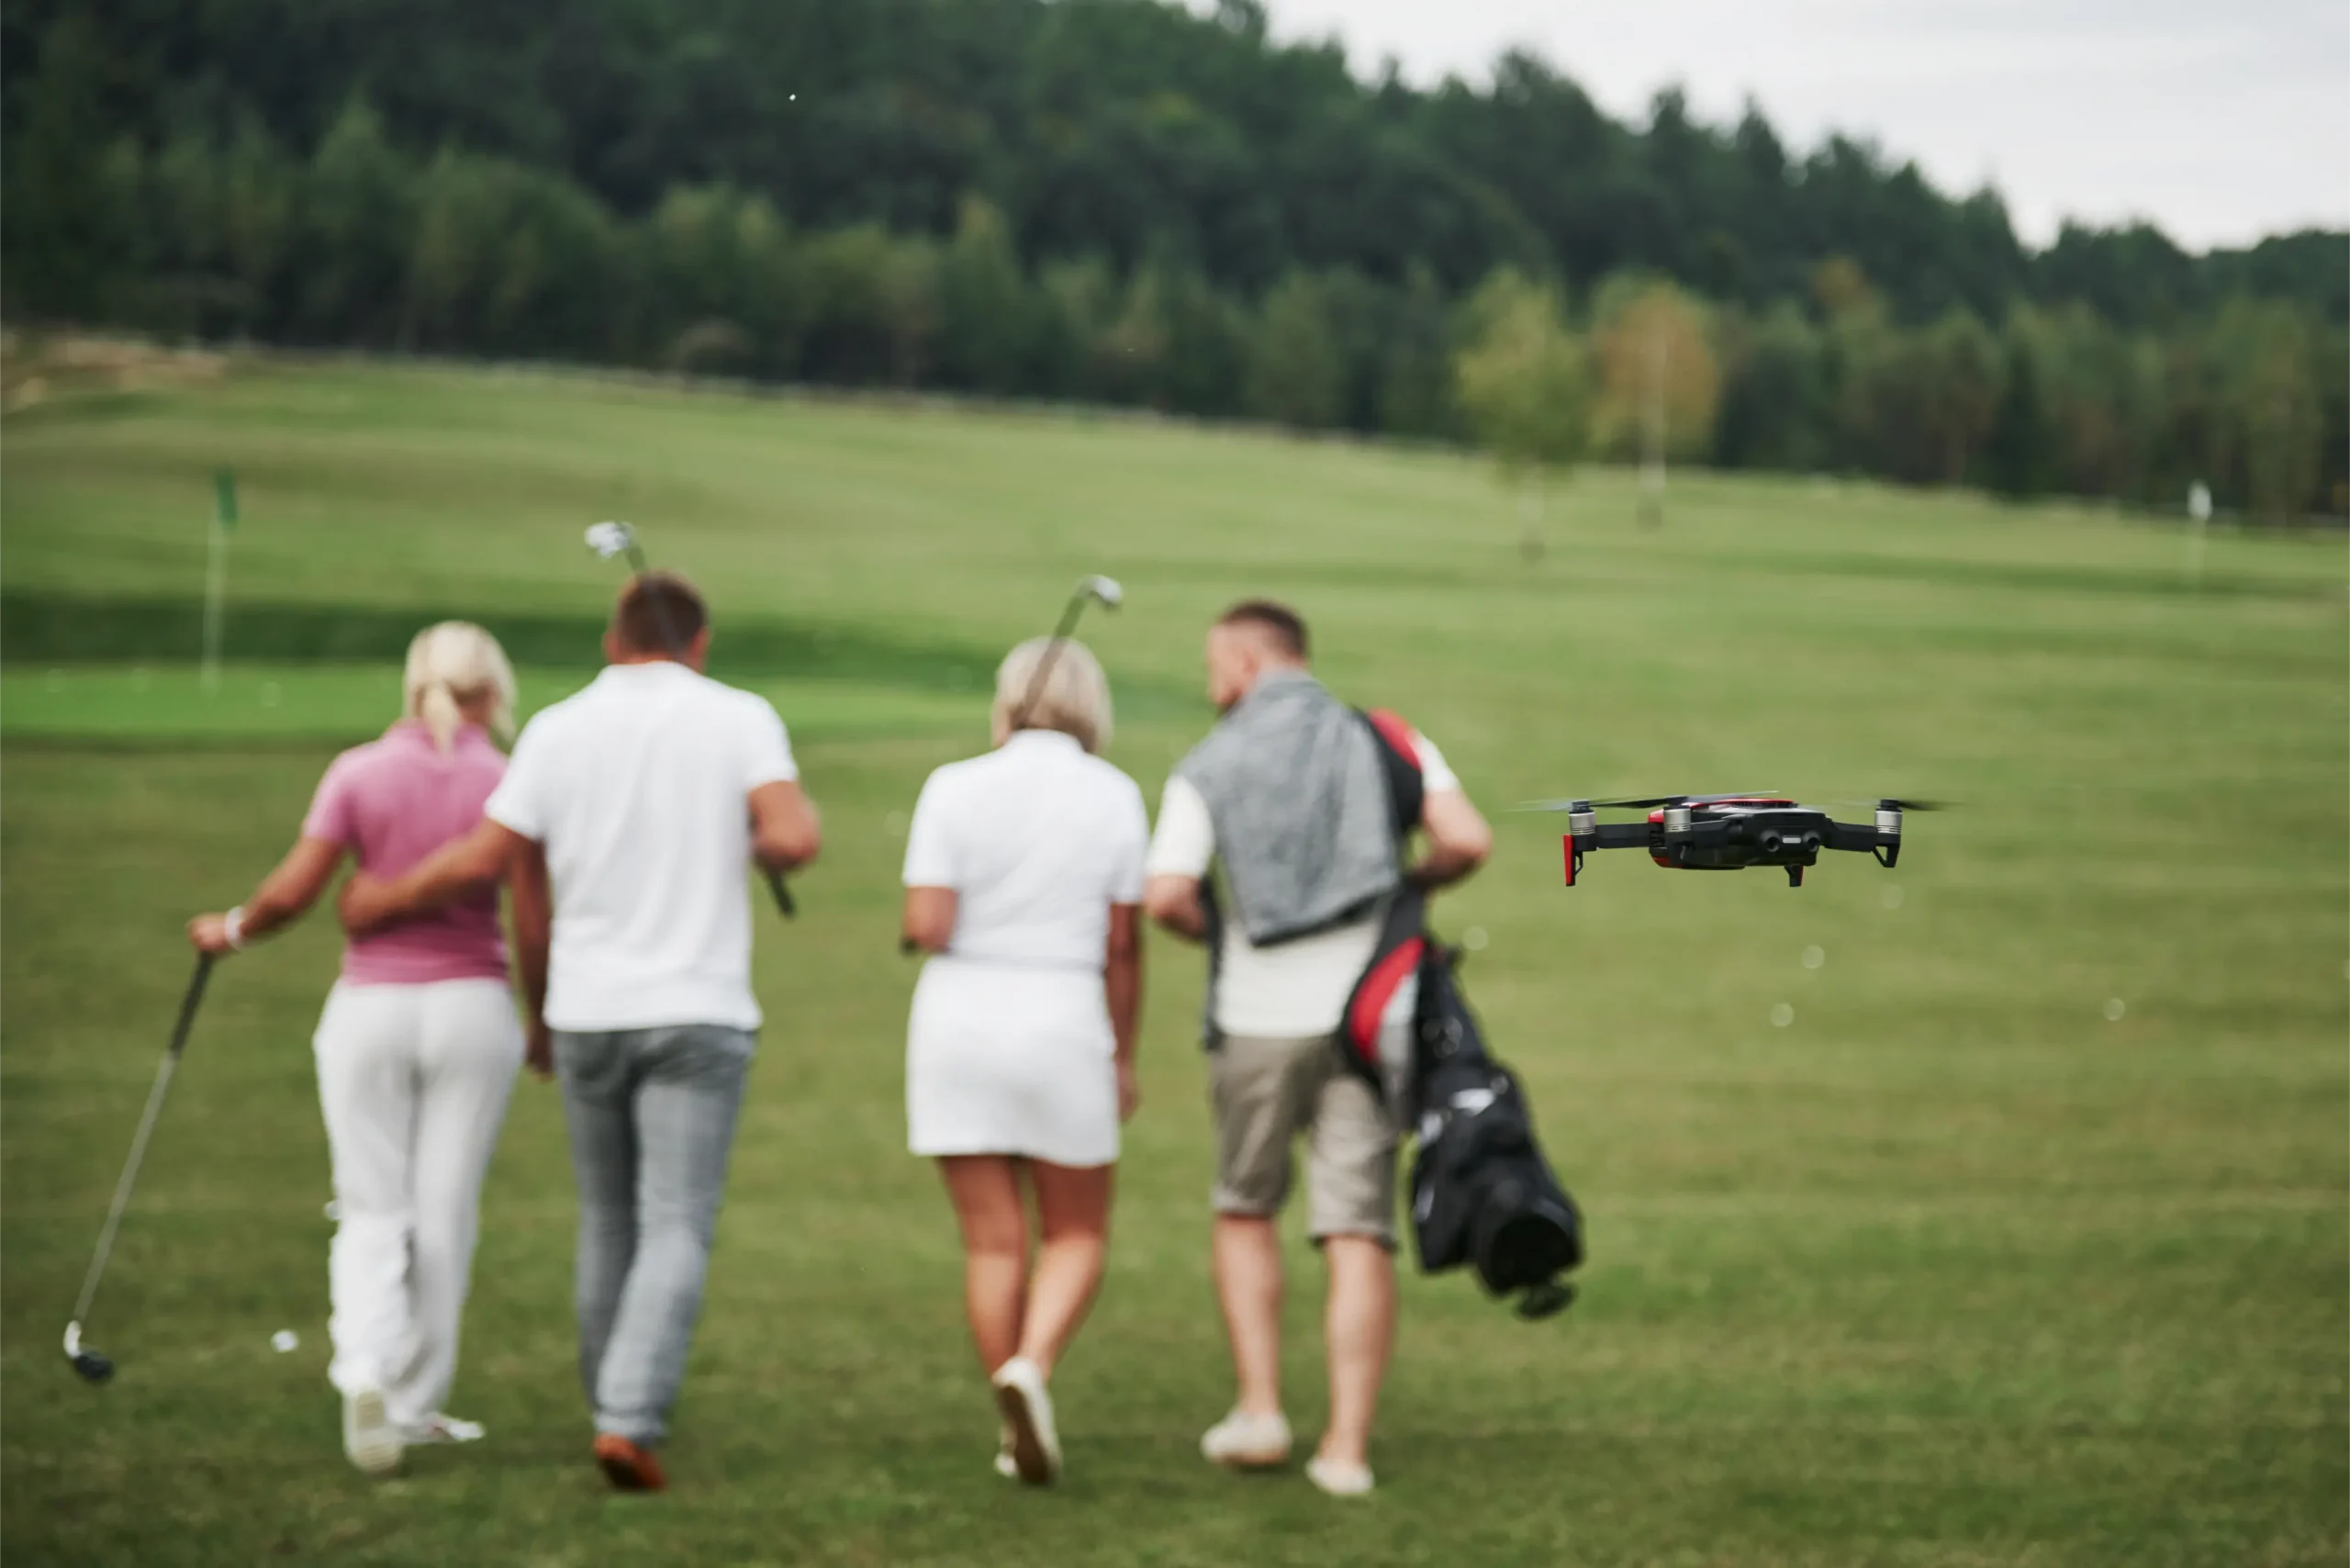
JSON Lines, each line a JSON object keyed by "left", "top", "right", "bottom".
{"left": 1240, "top": 0, "right": 2350, "bottom": 249}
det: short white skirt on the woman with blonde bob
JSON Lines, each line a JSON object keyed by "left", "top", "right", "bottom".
{"left": 905, "top": 957, "right": 1119, "bottom": 1169}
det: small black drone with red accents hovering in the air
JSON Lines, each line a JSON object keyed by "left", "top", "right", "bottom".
{"left": 1530, "top": 790, "right": 1936, "bottom": 886}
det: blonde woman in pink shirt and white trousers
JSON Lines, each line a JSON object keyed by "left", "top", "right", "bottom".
{"left": 188, "top": 621, "right": 529, "bottom": 1474}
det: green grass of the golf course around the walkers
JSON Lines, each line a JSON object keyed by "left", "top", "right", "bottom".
{"left": 0, "top": 369, "right": 2350, "bottom": 1568}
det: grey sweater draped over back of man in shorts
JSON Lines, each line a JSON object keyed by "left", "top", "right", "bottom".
{"left": 1175, "top": 670, "right": 1403, "bottom": 947}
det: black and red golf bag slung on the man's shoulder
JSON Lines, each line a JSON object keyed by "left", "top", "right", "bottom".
{"left": 1339, "top": 714, "right": 1583, "bottom": 1319}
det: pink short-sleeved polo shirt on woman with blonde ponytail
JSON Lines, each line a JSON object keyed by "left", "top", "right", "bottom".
{"left": 301, "top": 720, "right": 505, "bottom": 985}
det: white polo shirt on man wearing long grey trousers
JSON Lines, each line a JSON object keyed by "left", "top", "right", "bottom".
{"left": 484, "top": 661, "right": 799, "bottom": 1032}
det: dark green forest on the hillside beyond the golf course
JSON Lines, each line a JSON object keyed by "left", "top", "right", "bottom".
{"left": 0, "top": 0, "right": 2350, "bottom": 520}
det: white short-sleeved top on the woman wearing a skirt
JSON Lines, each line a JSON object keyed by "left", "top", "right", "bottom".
{"left": 905, "top": 729, "right": 1149, "bottom": 973}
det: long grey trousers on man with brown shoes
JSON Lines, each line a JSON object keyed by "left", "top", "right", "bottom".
{"left": 554, "top": 1025, "right": 756, "bottom": 1446}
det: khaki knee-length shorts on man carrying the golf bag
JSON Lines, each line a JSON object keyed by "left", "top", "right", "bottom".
{"left": 1208, "top": 1035, "right": 1396, "bottom": 1249}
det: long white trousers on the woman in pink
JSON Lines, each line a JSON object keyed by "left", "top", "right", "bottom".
{"left": 312, "top": 980, "right": 521, "bottom": 1425}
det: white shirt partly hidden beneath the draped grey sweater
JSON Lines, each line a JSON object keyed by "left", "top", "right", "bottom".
{"left": 1147, "top": 736, "right": 1461, "bottom": 1039}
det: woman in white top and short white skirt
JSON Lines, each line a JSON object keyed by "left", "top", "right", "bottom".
{"left": 905, "top": 640, "right": 1149, "bottom": 1485}
